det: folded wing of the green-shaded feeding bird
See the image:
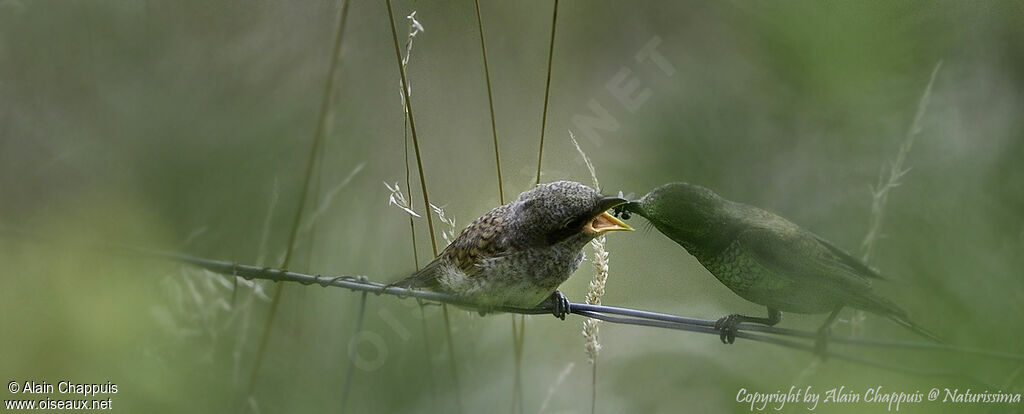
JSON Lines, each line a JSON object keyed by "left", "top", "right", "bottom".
{"left": 736, "top": 226, "right": 871, "bottom": 293}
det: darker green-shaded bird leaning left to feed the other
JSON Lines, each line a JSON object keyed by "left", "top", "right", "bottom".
{"left": 618, "top": 182, "right": 940, "bottom": 351}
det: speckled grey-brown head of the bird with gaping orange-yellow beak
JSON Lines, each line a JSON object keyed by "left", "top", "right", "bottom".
{"left": 515, "top": 181, "right": 633, "bottom": 248}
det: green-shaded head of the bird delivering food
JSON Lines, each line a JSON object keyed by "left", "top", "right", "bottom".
{"left": 621, "top": 182, "right": 730, "bottom": 252}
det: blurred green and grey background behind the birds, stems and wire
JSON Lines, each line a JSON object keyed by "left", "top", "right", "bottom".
{"left": 0, "top": 0, "right": 1024, "bottom": 413}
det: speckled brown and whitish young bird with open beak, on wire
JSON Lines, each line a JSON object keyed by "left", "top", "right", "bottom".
{"left": 391, "top": 181, "right": 633, "bottom": 320}
